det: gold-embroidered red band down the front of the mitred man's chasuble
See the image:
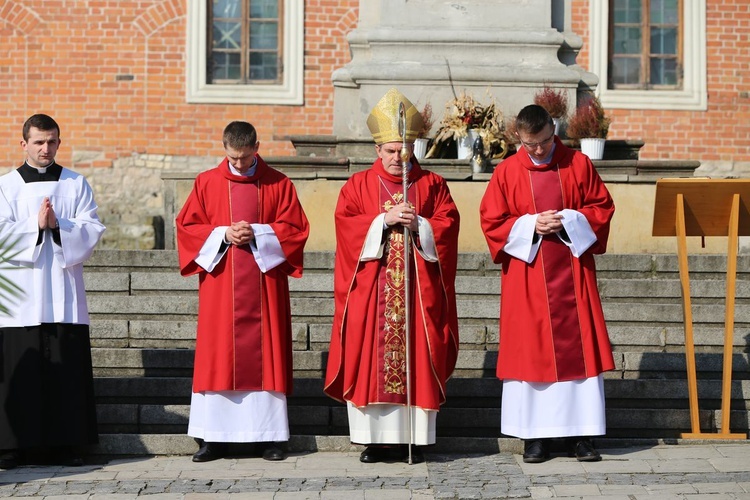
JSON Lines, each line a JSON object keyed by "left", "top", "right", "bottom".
{"left": 376, "top": 177, "right": 416, "bottom": 404}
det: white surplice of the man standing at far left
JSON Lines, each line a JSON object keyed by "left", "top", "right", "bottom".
{"left": 0, "top": 168, "right": 104, "bottom": 327}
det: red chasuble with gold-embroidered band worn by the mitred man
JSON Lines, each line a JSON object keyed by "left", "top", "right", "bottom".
{"left": 325, "top": 160, "right": 459, "bottom": 410}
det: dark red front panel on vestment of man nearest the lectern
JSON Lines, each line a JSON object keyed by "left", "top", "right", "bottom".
{"left": 529, "top": 166, "right": 586, "bottom": 380}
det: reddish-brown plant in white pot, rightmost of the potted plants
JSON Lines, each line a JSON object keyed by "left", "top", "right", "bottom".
{"left": 566, "top": 94, "right": 611, "bottom": 160}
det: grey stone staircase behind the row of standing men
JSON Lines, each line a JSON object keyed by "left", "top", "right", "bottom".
{"left": 85, "top": 250, "right": 750, "bottom": 455}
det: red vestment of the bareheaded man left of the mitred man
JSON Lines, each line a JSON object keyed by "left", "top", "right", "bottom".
{"left": 176, "top": 157, "right": 309, "bottom": 394}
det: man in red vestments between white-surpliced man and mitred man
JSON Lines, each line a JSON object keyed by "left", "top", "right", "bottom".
{"left": 177, "top": 121, "right": 309, "bottom": 462}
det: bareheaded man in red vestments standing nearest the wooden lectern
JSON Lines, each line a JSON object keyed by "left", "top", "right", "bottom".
{"left": 480, "top": 105, "right": 615, "bottom": 462}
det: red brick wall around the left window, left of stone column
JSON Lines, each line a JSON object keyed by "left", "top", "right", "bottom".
{"left": 0, "top": 0, "right": 359, "bottom": 167}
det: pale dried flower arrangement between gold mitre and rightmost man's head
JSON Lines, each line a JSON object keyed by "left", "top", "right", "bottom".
{"left": 427, "top": 92, "right": 508, "bottom": 158}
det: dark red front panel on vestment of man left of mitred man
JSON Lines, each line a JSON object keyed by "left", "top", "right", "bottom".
{"left": 228, "top": 182, "right": 263, "bottom": 389}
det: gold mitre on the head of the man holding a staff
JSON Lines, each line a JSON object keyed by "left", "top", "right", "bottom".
{"left": 367, "top": 89, "right": 424, "bottom": 144}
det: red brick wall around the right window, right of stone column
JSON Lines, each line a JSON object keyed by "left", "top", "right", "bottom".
{"left": 572, "top": 0, "right": 750, "bottom": 170}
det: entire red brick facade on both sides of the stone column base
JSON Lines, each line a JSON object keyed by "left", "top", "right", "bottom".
{"left": 0, "top": 0, "right": 750, "bottom": 167}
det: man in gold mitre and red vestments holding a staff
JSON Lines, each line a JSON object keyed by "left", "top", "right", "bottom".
{"left": 325, "top": 89, "right": 459, "bottom": 462}
